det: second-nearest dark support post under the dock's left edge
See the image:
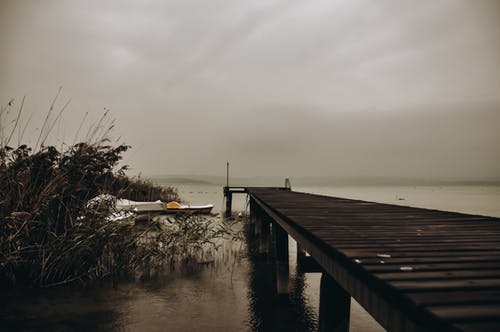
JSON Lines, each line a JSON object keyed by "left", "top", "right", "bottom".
{"left": 272, "top": 222, "right": 290, "bottom": 294}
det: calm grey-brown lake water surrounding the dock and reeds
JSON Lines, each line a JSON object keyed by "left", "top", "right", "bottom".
{"left": 0, "top": 184, "right": 500, "bottom": 332}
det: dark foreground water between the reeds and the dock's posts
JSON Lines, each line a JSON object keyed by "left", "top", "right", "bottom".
{"left": 0, "top": 218, "right": 317, "bottom": 331}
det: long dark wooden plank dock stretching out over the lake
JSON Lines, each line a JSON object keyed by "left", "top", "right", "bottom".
{"left": 237, "top": 188, "right": 500, "bottom": 332}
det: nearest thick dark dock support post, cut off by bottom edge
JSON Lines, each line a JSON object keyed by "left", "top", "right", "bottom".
{"left": 319, "top": 272, "right": 351, "bottom": 332}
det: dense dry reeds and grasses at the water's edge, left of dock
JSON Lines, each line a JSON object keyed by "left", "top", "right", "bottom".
{"left": 0, "top": 96, "right": 229, "bottom": 286}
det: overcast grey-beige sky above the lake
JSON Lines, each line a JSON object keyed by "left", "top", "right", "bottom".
{"left": 0, "top": 0, "right": 500, "bottom": 178}
